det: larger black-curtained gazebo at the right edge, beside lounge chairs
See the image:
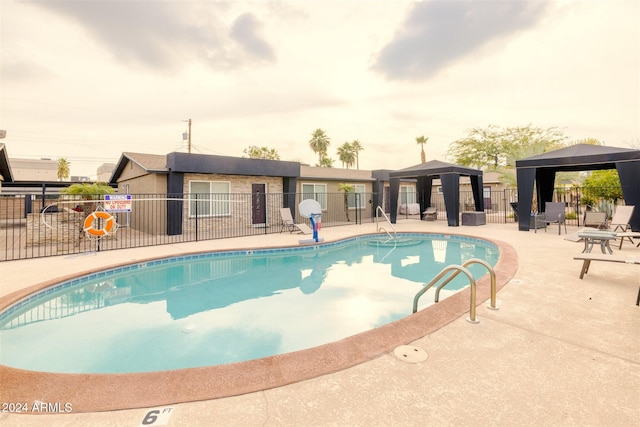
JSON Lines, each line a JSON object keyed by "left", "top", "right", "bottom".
{"left": 516, "top": 144, "right": 640, "bottom": 231}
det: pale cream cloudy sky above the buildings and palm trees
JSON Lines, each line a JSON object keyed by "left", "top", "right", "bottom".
{"left": 0, "top": 0, "right": 640, "bottom": 178}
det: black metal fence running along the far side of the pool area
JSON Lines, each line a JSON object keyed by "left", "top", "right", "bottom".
{"left": 0, "top": 188, "right": 611, "bottom": 261}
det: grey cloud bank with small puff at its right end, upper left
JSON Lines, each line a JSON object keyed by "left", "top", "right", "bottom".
{"left": 31, "top": 0, "right": 275, "bottom": 72}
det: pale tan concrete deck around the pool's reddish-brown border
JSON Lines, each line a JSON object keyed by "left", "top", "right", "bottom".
{"left": 0, "top": 220, "right": 640, "bottom": 426}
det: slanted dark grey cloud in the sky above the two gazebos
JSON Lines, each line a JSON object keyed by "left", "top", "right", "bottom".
{"left": 373, "top": 0, "right": 547, "bottom": 80}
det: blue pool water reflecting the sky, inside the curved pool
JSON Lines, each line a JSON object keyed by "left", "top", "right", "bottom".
{"left": 0, "top": 234, "right": 499, "bottom": 373}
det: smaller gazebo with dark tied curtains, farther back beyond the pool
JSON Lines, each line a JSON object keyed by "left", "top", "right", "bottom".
{"left": 389, "top": 160, "right": 484, "bottom": 227}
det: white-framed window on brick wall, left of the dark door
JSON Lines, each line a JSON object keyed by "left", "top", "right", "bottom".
{"left": 189, "top": 181, "right": 231, "bottom": 217}
